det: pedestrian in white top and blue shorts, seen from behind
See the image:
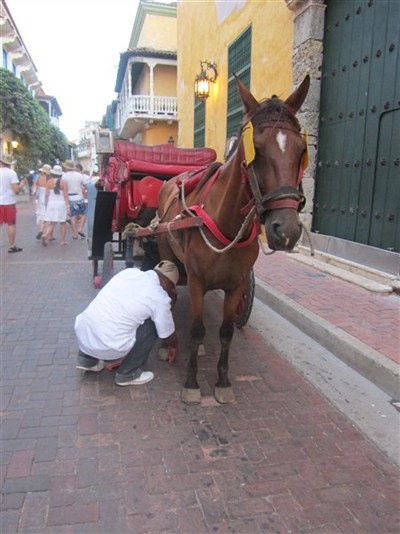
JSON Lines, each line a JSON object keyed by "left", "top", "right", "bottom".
{"left": 62, "top": 160, "right": 88, "bottom": 239}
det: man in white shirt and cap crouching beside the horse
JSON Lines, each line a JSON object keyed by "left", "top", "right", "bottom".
{"left": 75, "top": 261, "right": 179, "bottom": 386}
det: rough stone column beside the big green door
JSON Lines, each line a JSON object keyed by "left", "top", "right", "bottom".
{"left": 285, "top": 0, "right": 326, "bottom": 234}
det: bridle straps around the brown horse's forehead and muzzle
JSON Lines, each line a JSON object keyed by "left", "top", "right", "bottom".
{"left": 246, "top": 118, "right": 306, "bottom": 216}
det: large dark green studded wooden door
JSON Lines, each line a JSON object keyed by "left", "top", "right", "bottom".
{"left": 313, "top": 0, "right": 400, "bottom": 252}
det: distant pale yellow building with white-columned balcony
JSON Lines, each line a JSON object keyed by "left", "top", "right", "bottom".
{"left": 111, "top": 0, "right": 178, "bottom": 145}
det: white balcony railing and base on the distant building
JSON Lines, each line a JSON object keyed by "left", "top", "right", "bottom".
{"left": 118, "top": 95, "right": 178, "bottom": 138}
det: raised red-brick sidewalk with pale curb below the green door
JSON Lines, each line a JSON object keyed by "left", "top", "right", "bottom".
{"left": 254, "top": 252, "right": 400, "bottom": 399}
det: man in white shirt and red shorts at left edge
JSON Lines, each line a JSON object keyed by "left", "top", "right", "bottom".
{"left": 0, "top": 154, "right": 27, "bottom": 253}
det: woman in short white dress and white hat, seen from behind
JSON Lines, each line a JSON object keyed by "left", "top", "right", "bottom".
{"left": 42, "top": 165, "right": 69, "bottom": 246}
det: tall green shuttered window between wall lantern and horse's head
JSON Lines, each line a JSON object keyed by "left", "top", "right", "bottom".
{"left": 226, "top": 26, "right": 251, "bottom": 138}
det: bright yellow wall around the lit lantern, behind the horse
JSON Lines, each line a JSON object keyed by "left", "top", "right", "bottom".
{"left": 177, "top": 0, "right": 293, "bottom": 161}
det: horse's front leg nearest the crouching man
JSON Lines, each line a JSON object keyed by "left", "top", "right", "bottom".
{"left": 182, "top": 279, "right": 205, "bottom": 404}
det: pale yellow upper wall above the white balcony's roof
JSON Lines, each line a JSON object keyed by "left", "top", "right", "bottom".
{"left": 136, "top": 14, "right": 177, "bottom": 51}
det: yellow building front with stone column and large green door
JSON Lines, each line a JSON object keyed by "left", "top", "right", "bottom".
{"left": 177, "top": 0, "right": 400, "bottom": 267}
